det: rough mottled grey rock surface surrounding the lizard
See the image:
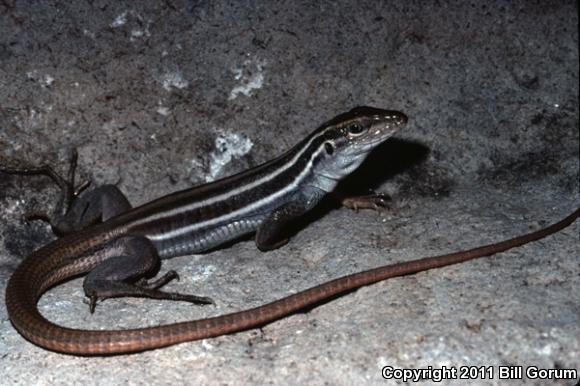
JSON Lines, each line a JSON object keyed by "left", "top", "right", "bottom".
{"left": 0, "top": 0, "right": 580, "bottom": 385}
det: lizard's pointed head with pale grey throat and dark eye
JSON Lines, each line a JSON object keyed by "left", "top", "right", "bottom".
{"left": 312, "top": 107, "right": 407, "bottom": 192}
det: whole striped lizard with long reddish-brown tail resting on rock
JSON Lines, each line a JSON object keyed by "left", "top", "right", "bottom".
{"left": 0, "top": 107, "right": 579, "bottom": 355}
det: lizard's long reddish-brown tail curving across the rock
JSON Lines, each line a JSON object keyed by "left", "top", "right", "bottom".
{"left": 6, "top": 209, "right": 580, "bottom": 355}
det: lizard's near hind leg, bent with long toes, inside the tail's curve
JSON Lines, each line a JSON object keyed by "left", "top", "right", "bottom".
{"left": 83, "top": 236, "right": 214, "bottom": 313}
